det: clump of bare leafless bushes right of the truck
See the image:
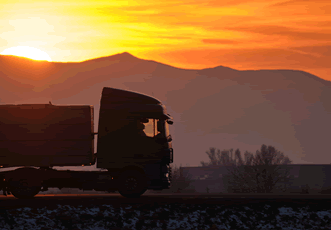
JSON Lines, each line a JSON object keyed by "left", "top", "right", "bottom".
{"left": 200, "top": 145, "right": 292, "bottom": 193}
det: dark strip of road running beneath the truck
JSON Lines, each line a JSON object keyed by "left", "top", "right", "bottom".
{"left": 0, "top": 194, "right": 331, "bottom": 209}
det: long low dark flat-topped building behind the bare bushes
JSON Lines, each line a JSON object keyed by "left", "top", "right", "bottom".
{"left": 180, "top": 164, "right": 331, "bottom": 193}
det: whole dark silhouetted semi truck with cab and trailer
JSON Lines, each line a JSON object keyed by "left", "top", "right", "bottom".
{"left": 0, "top": 87, "right": 173, "bottom": 199}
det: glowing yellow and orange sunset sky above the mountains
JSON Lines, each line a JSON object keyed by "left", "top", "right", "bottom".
{"left": 0, "top": 0, "right": 331, "bottom": 80}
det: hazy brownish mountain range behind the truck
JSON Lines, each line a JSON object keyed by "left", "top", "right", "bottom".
{"left": 0, "top": 53, "right": 331, "bottom": 166}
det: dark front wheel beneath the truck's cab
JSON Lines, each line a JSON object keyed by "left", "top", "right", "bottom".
{"left": 118, "top": 170, "right": 147, "bottom": 198}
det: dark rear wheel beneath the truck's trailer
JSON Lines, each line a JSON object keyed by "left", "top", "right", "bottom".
{"left": 9, "top": 179, "right": 41, "bottom": 199}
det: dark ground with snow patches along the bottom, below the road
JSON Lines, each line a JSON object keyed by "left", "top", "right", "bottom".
{"left": 0, "top": 199, "right": 331, "bottom": 230}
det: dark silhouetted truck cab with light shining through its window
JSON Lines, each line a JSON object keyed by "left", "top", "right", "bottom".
{"left": 97, "top": 87, "right": 173, "bottom": 197}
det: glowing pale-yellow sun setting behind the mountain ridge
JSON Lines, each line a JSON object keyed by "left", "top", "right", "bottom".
{"left": 1, "top": 46, "right": 52, "bottom": 61}
